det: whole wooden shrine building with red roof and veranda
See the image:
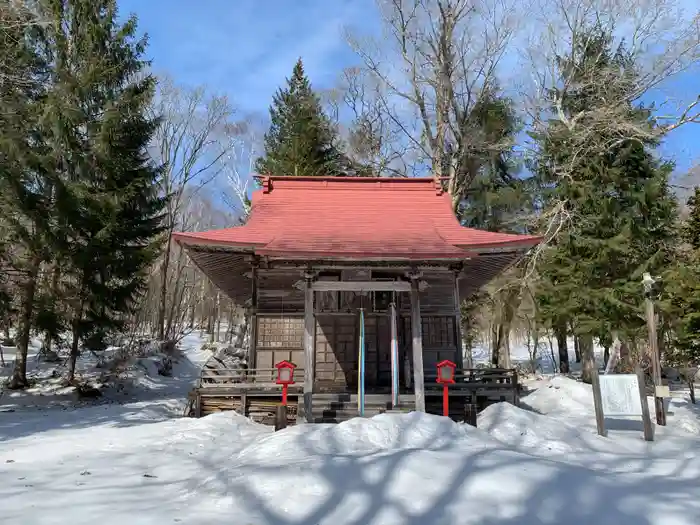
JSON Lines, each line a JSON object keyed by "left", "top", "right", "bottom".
{"left": 176, "top": 177, "right": 539, "bottom": 422}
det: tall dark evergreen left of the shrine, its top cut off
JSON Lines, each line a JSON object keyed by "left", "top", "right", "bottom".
{"left": 34, "top": 0, "right": 165, "bottom": 379}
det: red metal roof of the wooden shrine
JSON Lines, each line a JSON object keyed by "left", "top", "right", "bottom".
{"left": 175, "top": 177, "right": 540, "bottom": 260}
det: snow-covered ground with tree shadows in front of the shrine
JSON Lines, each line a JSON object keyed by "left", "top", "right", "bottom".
{"left": 0, "top": 334, "right": 700, "bottom": 525}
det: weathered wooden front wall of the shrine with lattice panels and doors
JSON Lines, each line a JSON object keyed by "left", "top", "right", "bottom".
{"left": 256, "top": 270, "right": 459, "bottom": 389}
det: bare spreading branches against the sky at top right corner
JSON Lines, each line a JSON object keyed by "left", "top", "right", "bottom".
{"left": 523, "top": 0, "right": 700, "bottom": 192}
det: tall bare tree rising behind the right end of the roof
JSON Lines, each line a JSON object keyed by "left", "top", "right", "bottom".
{"left": 350, "top": 0, "right": 516, "bottom": 205}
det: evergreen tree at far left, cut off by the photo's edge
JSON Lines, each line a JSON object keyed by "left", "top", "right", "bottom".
{"left": 0, "top": 2, "right": 54, "bottom": 388}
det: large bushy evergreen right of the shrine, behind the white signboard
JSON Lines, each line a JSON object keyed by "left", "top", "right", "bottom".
{"left": 537, "top": 29, "right": 676, "bottom": 376}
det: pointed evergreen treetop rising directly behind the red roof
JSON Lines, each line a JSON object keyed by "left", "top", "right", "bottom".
{"left": 256, "top": 59, "right": 349, "bottom": 176}
